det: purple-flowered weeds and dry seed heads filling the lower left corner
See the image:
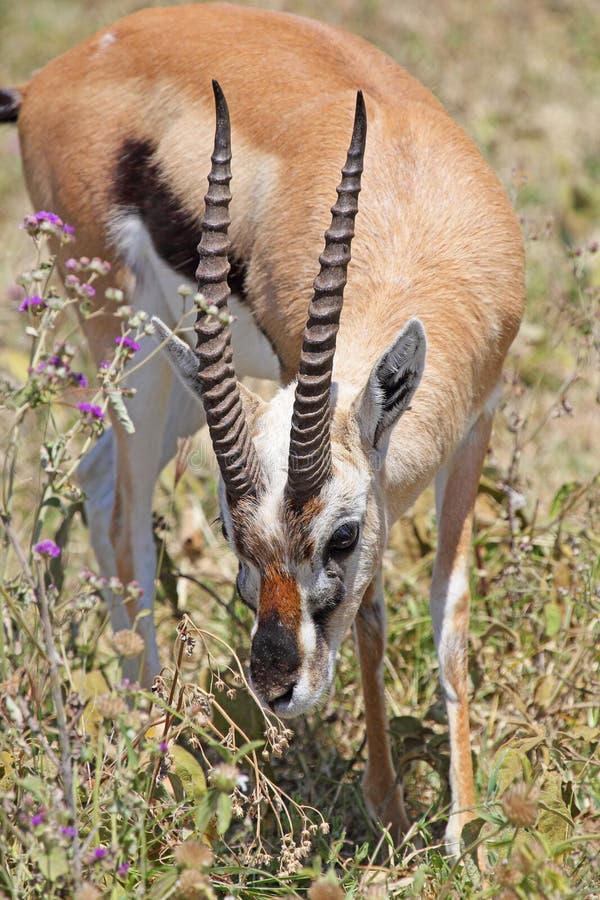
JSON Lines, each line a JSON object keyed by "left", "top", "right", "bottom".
{"left": 0, "top": 211, "right": 327, "bottom": 898}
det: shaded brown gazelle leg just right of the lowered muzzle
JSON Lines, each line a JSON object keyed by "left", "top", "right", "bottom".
{"left": 355, "top": 572, "right": 410, "bottom": 838}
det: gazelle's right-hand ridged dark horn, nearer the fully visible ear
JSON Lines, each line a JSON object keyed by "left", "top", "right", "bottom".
{"left": 286, "top": 91, "right": 367, "bottom": 506}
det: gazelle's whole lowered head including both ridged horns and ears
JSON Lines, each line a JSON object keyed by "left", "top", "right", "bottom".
{"left": 153, "top": 82, "right": 425, "bottom": 716}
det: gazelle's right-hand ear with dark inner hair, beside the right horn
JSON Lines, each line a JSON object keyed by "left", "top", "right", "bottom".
{"left": 357, "top": 319, "right": 427, "bottom": 450}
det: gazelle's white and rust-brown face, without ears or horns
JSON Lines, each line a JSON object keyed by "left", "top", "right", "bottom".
{"left": 221, "top": 388, "right": 386, "bottom": 716}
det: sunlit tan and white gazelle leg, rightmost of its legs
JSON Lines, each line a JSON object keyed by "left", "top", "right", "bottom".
{"left": 430, "top": 411, "right": 492, "bottom": 856}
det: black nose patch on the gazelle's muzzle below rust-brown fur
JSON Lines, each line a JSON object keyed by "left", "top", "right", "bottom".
{"left": 250, "top": 615, "right": 300, "bottom": 704}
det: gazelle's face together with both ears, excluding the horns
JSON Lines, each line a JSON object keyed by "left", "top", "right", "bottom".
{"left": 153, "top": 310, "right": 426, "bottom": 716}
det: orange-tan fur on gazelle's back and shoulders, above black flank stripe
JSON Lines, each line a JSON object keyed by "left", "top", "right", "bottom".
{"left": 20, "top": 4, "right": 523, "bottom": 388}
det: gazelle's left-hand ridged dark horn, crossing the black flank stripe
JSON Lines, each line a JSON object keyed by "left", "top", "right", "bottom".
{"left": 195, "top": 81, "right": 263, "bottom": 502}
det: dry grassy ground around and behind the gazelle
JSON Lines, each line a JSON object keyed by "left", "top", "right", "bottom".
{"left": 0, "top": 0, "right": 600, "bottom": 900}
